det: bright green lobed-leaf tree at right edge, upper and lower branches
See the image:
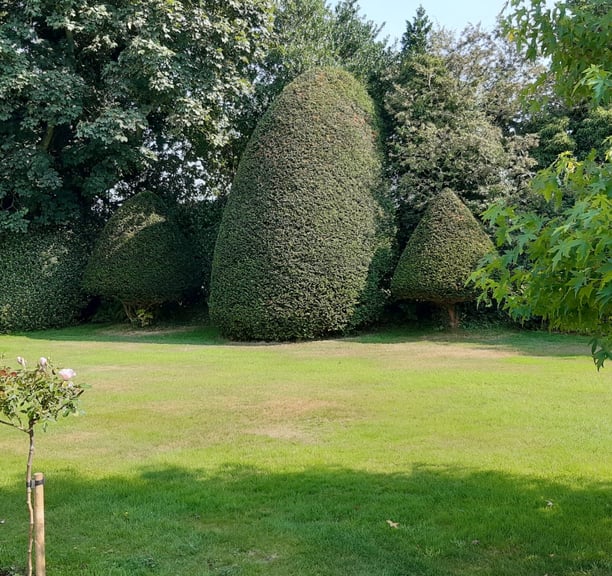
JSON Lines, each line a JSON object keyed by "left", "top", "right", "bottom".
{"left": 473, "top": 0, "right": 612, "bottom": 368}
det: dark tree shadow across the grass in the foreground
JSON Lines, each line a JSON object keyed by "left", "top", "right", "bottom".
{"left": 0, "top": 465, "right": 612, "bottom": 576}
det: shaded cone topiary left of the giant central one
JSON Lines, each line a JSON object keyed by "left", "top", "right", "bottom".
{"left": 83, "top": 192, "right": 200, "bottom": 320}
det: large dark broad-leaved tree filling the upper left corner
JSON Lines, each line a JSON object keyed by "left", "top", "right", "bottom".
{"left": 0, "top": 0, "right": 271, "bottom": 231}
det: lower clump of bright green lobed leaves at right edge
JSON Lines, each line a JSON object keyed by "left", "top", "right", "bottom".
{"left": 473, "top": 154, "right": 612, "bottom": 366}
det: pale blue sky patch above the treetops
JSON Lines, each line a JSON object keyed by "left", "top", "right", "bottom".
{"left": 331, "top": 0, "right": 506, "bottom": 40}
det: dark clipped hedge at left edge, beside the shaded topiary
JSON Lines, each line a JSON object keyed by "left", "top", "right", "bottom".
{"left": 0, "top": 229, "right": 89, "bottom": 332}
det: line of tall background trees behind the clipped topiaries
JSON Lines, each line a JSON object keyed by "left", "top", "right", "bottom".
{"left": 0, "top": 0, "right": 612, "bottom": 356}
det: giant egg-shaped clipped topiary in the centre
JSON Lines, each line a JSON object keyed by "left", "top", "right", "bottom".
{"left": 209, "top": 69, "right": 393, "bottom": 340}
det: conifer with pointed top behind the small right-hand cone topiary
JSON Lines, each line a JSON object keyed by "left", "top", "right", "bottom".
{"left": 385, "top": 12, "right": 525, "bottom": 245}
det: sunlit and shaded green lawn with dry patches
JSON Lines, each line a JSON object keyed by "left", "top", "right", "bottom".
{"left": 0, "top": 327, "right": 612, "bottom": 576}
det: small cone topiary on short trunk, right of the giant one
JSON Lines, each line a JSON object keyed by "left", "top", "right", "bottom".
{"left": 391, "top": 188, "right": 494, "bottom": 328}
